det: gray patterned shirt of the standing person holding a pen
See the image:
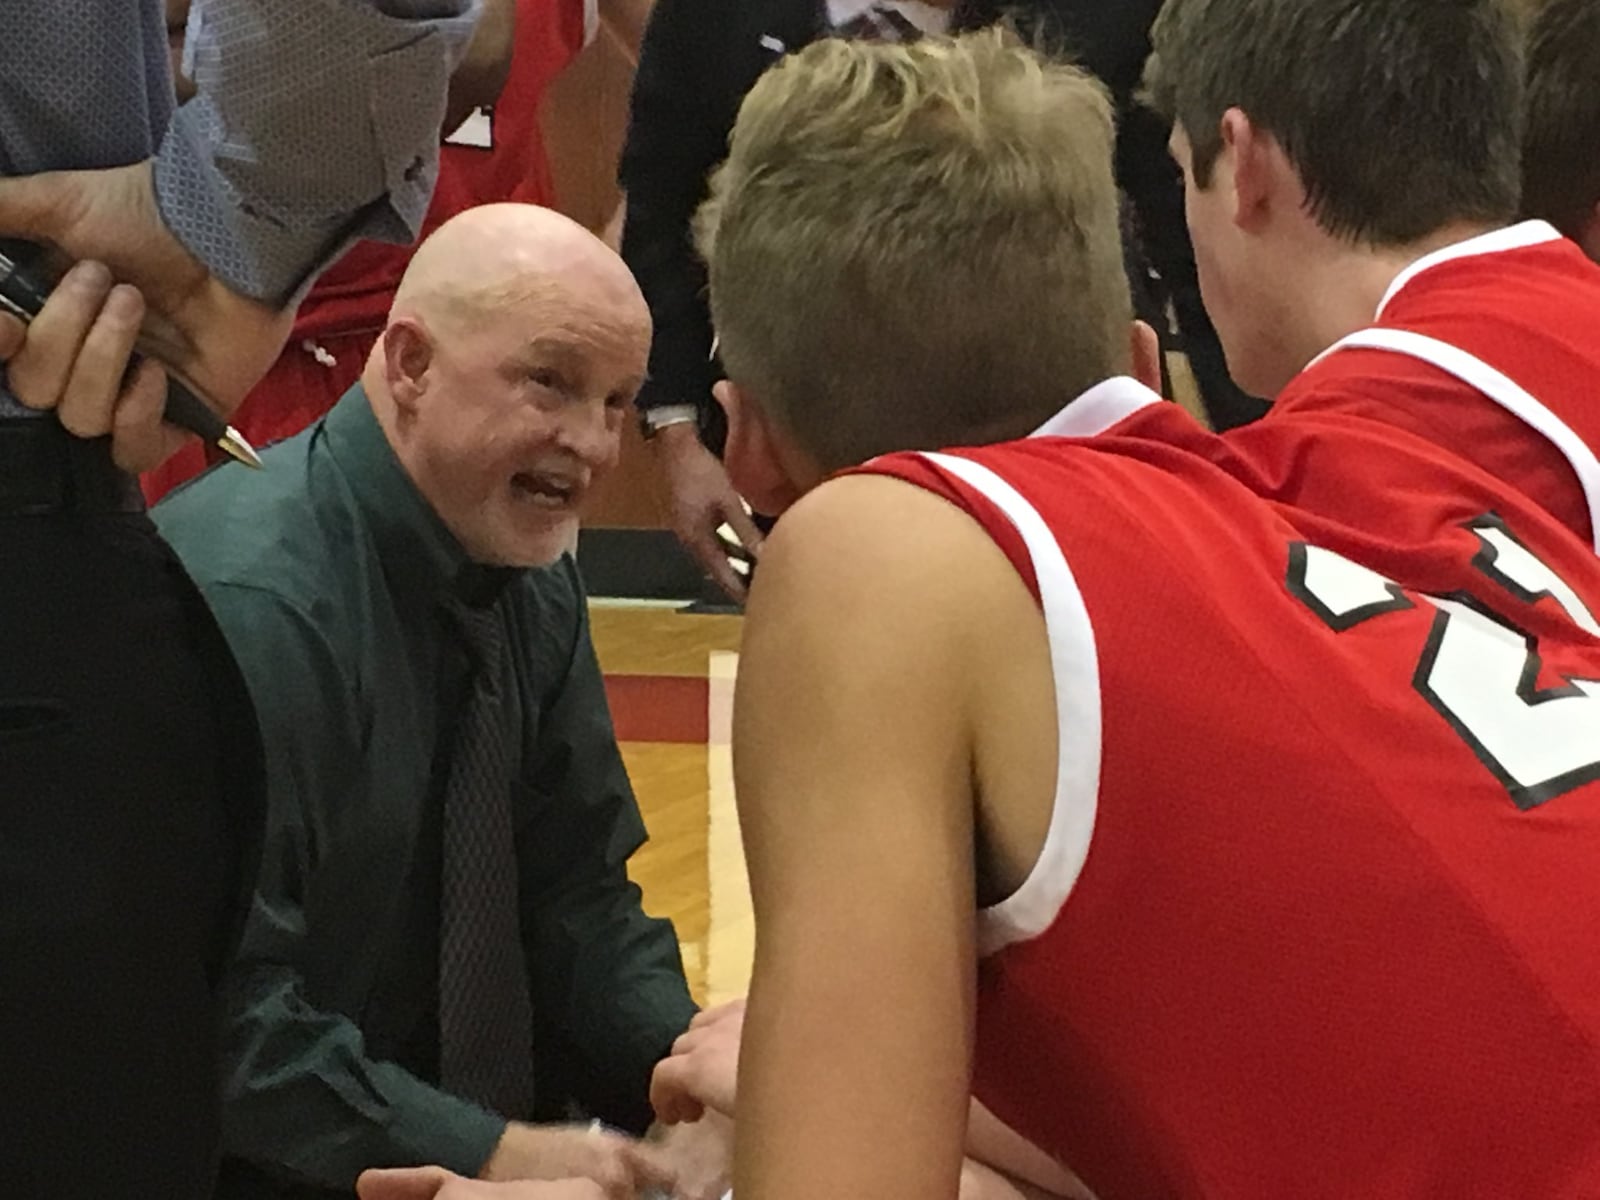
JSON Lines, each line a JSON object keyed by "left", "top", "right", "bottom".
{"left": 0, "top": 0, "right": 478, "bottom": 310}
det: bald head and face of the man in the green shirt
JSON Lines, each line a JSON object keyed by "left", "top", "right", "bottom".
{"left": 377, "top": 203, "right": 650, "bottom": 566}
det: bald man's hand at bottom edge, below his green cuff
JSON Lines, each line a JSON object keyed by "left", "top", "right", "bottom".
{"left": 483, "top": 1122, "right": 675, "bottom": 1200}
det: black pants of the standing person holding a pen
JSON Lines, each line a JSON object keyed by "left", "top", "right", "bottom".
{"left": 0, "top": 514, "right": 261, "bottom": 1200}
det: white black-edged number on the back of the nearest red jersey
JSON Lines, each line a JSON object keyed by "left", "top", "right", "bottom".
{"left": 1288, "top": 517, "right": 1600, "bottom": 810}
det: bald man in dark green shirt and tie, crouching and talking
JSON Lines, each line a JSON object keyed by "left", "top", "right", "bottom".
{"left": 155, "top": 205, "right": 694, "bottom": 1198}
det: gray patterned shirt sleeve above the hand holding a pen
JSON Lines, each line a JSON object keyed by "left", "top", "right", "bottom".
{"left": 155, "top": 0, "right": 478, "bottom": 304}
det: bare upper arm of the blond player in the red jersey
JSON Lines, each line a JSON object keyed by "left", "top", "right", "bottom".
{"left": 734, "top": 478, "right": 1008, "bottom": 1200}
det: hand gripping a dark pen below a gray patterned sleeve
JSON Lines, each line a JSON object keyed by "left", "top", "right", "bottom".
{"left": 0, "top": 162, "right": 293, "bottom": 470}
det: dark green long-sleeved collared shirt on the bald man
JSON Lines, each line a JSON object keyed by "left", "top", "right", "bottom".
{"left": 154, "top": 386, "right": 694, "bottom": 1195}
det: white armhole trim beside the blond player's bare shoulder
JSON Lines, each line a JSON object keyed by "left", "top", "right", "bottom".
{"left": 923, "top": 454, "right": 1101, "bottom": 955}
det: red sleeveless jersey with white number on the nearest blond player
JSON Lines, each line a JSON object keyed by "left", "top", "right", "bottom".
{"left": 866, "top": 381, "right": 1600, "bottom": 1200}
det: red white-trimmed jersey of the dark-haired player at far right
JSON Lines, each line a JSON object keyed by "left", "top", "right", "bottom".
{"left": 1227, "top": 221, "right": 1600, "bottom": 549}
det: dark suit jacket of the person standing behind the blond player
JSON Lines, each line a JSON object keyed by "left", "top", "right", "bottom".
{"left": 621, "top": 0, "right": 1165, "bottom": 445}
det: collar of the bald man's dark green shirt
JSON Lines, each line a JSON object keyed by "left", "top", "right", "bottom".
{"left": 322, "top": 384, "right": 492, "bottom": 605}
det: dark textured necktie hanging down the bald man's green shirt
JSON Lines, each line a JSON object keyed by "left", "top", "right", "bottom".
{"left": 438, "top": 605, "right": 533, "bottom": 1117}
